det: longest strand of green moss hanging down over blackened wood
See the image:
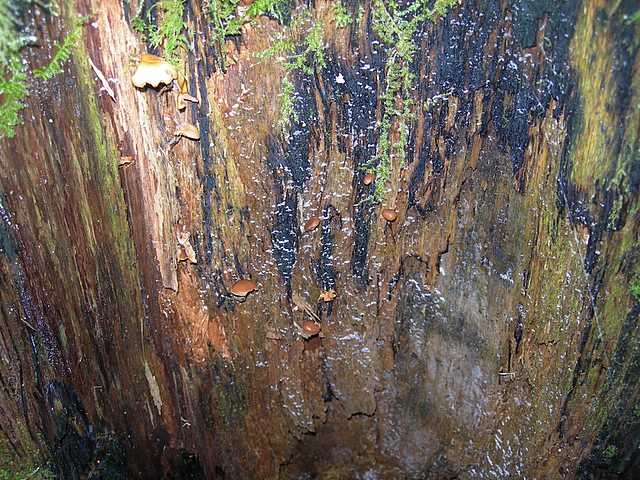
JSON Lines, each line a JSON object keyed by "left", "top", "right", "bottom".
{"left": 366, "top": 0, "right": 459, "bottom": 202}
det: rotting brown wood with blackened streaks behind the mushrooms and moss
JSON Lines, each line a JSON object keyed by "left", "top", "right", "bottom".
{"left": 0, "top": 0, "right": 640, "bottom": 479}
